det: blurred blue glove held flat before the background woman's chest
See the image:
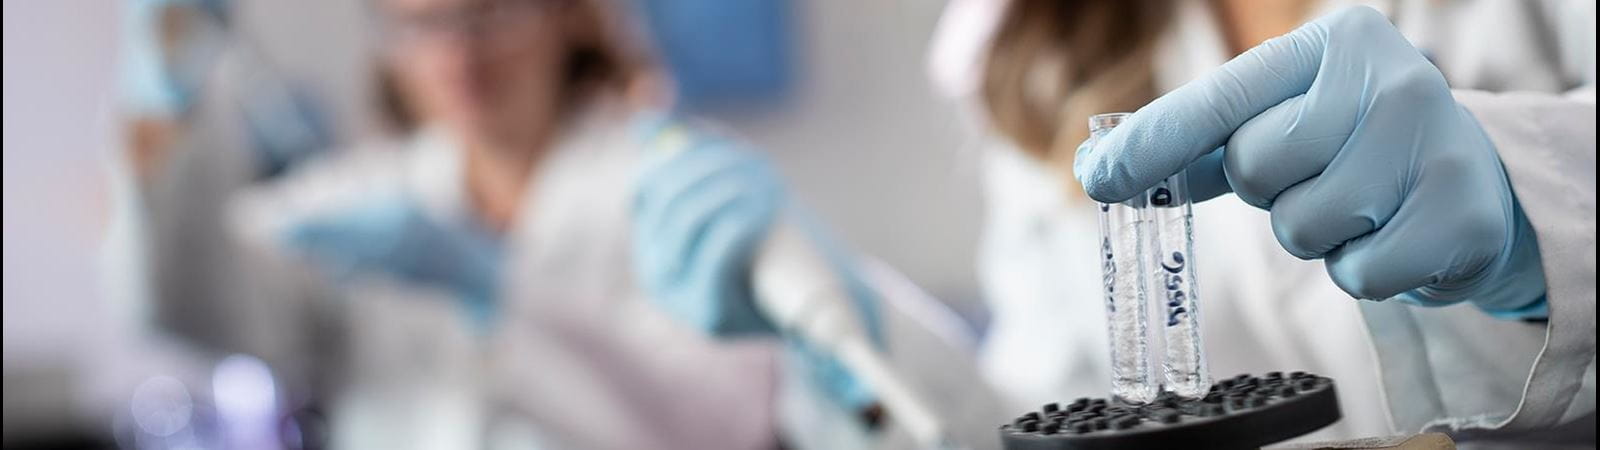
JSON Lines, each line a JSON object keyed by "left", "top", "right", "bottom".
{"left": 283, "top": 197, "right": 502, "bottom": 327}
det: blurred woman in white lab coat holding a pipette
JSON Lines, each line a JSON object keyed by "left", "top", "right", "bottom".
{"left": 234, "top": 0, "right": 1000, "bottom": 448}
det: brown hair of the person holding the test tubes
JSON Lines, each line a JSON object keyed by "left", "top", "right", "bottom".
{"left": 982, "top": 0, "right": 1171, "bottom": 172}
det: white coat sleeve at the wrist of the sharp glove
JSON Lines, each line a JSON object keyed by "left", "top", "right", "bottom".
{"left": 1456, "top": 88, "right": 1595, "bottom": 431}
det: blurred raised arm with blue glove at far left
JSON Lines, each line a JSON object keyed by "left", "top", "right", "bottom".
{"left": 110, "top": 0, "right": 333, "bottom": 347}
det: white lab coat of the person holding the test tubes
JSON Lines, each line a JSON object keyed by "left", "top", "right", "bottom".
{"left": 930, "top": 0, "right": 1595, "bottom": 447}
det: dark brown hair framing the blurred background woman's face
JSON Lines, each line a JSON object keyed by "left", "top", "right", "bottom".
{"left": 374, "top": 0, "right": 653, "bottom": 131}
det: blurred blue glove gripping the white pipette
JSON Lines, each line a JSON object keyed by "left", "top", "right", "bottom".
{"left": 634, "top": 115, "right": 883, "bottom": 408}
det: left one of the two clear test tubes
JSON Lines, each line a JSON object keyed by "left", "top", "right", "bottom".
{"left": 1090, "top": 114, "right": 1160, "bottom": 404}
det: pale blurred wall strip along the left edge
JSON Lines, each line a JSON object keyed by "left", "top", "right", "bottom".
{"left": 3, "top": 0, "right": 120, "bottom": 368}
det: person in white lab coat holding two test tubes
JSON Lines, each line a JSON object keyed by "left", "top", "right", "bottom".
{"left": 930, "top": 0, "right": 1595, "bottom": 448}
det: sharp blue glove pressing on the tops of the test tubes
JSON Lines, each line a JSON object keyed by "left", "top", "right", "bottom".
{"left": 1074, "top": 6, "right": 1547, "bottom": 319}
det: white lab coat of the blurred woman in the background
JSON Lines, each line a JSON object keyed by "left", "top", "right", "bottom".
{"left": 235, "top": 102, "right": 1005, "bottom": 448}
